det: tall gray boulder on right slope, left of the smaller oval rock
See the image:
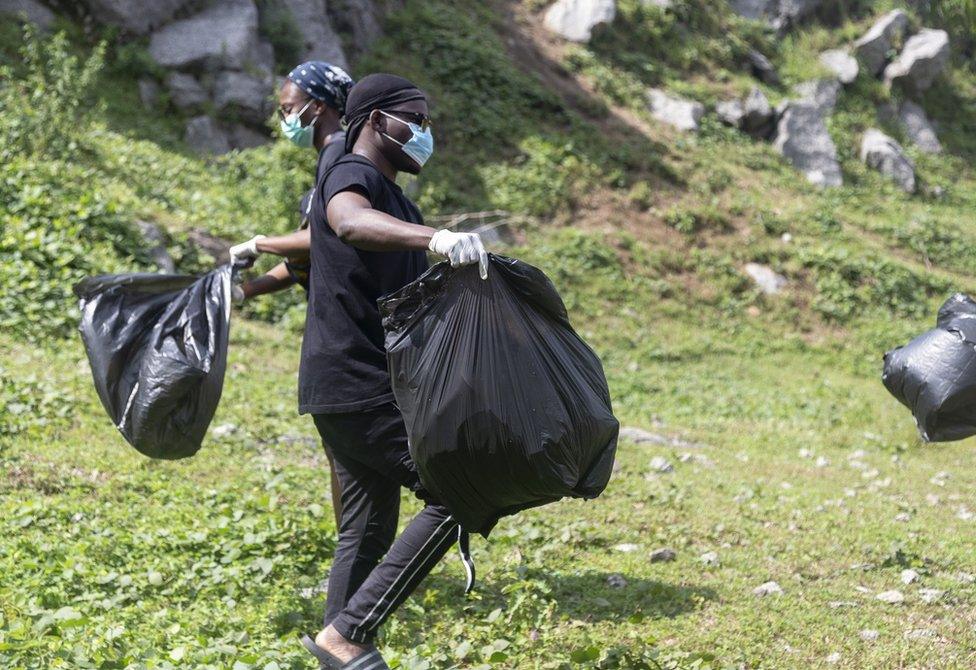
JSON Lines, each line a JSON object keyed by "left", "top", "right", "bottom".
{"left": 773, "top": 101, "right": 844, "bottom": 187}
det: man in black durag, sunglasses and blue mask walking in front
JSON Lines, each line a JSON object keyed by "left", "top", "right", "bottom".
{"left": 299, "top": 74, "right": 488, "bottom": 670}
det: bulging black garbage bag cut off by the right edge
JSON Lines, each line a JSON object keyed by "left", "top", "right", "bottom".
{"left": 881, "top": 293, "right": 976, "bottom": 442}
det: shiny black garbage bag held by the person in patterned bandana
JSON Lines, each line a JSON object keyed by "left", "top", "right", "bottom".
{"left": 74, "top": 265, "right": 231, "bottom": 459}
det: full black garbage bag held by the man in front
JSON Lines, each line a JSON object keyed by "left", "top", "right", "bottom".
{"left": 380, "top": 255, "right": 619, "bottom": 536}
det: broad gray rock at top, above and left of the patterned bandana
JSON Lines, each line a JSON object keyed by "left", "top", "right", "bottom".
{"left": 149, "top": 0, "right": 258, "bottom": 69}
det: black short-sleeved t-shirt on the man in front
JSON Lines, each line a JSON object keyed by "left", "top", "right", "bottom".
{"left": 298, "top": 154, "right": 427, "bottom": 414}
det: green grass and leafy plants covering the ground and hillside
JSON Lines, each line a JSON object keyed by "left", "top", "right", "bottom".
{"left": 0, "top": 0, "right": 976, "bottom": 670}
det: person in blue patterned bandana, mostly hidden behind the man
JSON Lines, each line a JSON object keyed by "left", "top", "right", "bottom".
{"left": 230, "top": 61, "right": 353, "bottom": 527}
